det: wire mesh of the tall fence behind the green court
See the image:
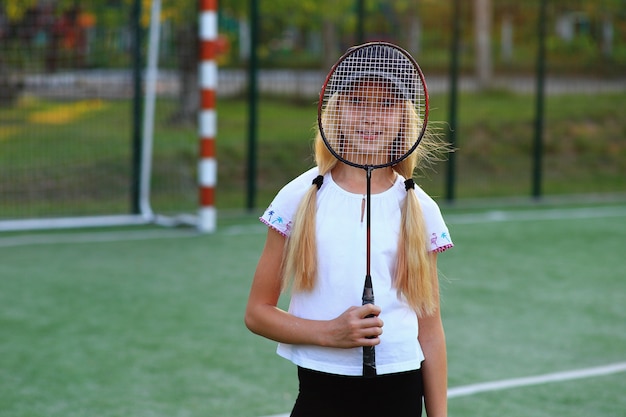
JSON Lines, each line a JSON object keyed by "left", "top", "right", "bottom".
{"left": 0, "top": 1, "right": 626, "bottom": 228}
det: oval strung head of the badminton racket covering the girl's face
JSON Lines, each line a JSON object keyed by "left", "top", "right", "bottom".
{"left": 320, "top": 44, "right": 427, "bottom": 167}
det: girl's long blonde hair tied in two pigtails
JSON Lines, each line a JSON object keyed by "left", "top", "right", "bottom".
{"left": 282, "top": 94, "right": 446, "bottom": 316}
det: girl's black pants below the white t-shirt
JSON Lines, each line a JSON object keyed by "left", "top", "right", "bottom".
{"left": 291, "top": 368, "right": 424, "bottom": 417}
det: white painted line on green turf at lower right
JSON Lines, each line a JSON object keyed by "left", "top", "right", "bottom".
{"left": 258, "top": 362, "right": 626, "bottom": 417}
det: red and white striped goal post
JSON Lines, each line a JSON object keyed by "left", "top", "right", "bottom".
{"left": 198, "top": 0, "right": 217, "bottom": 232}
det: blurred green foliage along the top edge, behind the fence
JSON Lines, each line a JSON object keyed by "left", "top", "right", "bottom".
{"left": 5, "top": 0, "right": 626, "bottom": 76}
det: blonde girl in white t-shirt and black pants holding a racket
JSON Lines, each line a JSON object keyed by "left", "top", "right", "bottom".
{"left": 245, "top": 45, "right": 452, "bottom": 417}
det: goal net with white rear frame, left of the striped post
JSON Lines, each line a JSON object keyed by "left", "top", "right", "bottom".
{"left": 0, "top": 2, "right": 197, "bottom": 231}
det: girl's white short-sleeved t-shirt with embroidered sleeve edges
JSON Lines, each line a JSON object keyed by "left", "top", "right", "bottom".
{"left": 261, "top": 168, "right": 453, "bottom": 375}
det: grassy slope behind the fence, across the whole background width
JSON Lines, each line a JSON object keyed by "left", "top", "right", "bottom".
{"left": 0, "top": 91, "right": 626, "bottom": 217}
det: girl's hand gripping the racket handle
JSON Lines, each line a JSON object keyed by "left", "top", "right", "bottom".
{"left": 325, "top": 304, "right": 384, "bottom": 349}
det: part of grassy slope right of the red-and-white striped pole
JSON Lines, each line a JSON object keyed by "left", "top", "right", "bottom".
{"left": 218, "top": 92, "right": 626, "bottom": 207}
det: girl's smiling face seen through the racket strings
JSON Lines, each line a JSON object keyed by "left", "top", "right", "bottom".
{"left": 340, "top": 80, "right": 403, "bottom": 165}
